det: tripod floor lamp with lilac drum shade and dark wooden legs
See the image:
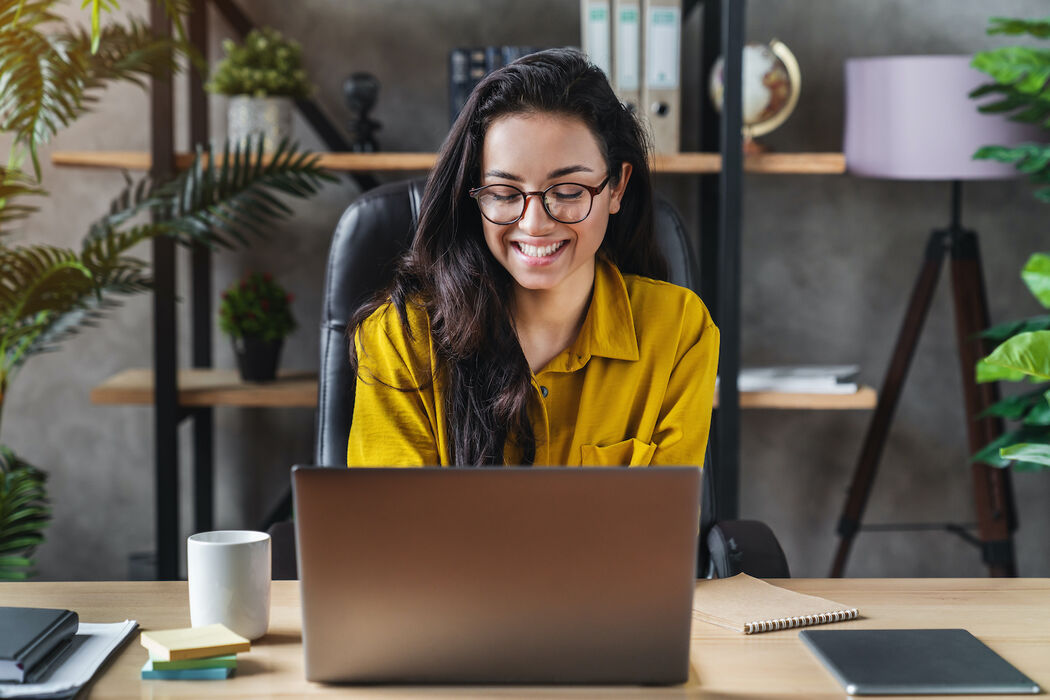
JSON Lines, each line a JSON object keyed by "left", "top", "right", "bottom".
{"left": 831, "top": 56, "right": 1032, "bottom": 577}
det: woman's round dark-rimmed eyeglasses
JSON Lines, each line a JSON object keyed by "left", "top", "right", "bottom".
{"left": 468, "top": 177, "right": 609, "bottom": 226}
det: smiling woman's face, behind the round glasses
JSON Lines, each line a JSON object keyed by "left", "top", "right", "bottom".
{"left": 478, "top": 113, "right": 631, "bottom": 294}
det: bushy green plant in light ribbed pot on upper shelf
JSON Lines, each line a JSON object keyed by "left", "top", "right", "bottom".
{"left": 205, "top": 28, "right": 314, "bottom": 150}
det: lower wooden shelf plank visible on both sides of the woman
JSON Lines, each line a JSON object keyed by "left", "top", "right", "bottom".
{"left": 91, "top": 369, "right": 878, "bottom": 410}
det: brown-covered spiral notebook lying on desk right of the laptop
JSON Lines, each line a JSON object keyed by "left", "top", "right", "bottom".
{"left": 693, "top": 574, "right": 858, "bottom": 634}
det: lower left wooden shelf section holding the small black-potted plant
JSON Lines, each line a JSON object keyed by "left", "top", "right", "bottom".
{"left": 91, "top": 369, "right": 317, "bottom": 408}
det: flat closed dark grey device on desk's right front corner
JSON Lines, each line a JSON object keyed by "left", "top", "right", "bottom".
{"left": 798, "top": 630, "right": 1040, "bottom": 695}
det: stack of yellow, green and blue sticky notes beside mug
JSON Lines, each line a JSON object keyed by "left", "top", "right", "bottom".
{"left": 141, "top": 624, "right": 251, "bottom": 680}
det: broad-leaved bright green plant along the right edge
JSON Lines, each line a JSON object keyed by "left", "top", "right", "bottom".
{"left": 970, "top": 17, "right": 1050, "bottom": 469}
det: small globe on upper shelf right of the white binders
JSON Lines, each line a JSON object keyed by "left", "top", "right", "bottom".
{"left": 708, "top": 39, "right": 802, "bottom": 141}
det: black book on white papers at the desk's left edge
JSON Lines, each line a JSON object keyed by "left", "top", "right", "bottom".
{"left": 0, "top": 607, "right": 80, "bottom": 683}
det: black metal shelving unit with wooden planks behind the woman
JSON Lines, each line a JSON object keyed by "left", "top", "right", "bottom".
{"left": 63, "top": 0, "right": 876, "bottom": 579}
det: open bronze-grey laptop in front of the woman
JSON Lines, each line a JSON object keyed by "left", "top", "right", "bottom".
{"left": 292, "top": 466, "right": 700, "bottom": 684}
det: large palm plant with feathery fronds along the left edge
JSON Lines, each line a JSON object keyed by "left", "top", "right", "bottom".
{"left": 0, "top": 0, "right": 333, "bottom": 579}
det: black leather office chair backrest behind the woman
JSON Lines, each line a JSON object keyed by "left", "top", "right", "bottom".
{"left": 314, "top": 179, "right": 715, "bottom": 565}
